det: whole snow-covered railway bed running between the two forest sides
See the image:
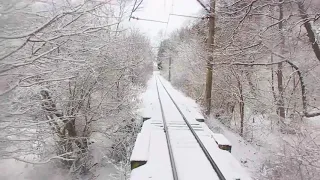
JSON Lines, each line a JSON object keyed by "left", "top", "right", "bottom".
{"left": 131, "top": 72, "right": 250, "bottom": 180}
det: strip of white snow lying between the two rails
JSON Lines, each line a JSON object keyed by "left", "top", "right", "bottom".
{"left": 155, "top": 76, "right": 219, "bottom": 180}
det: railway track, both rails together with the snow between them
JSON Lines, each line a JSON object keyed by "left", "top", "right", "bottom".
{"left": 155, "top": 76, "right": 226, "bottom": 180}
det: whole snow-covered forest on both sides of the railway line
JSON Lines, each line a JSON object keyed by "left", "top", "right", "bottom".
{"left": 0, "top": 0, "right": 320, "bottom": 180}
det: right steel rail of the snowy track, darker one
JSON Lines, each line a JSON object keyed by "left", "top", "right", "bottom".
{"left": 157, "top": 78, "right": 226, "bottom": 180}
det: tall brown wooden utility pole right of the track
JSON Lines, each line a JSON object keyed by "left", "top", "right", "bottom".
{"left": 205, "top": 0, "right": 215, "bottom": 115}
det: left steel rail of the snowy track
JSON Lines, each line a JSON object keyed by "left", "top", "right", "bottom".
{"left": 155, "top": 76, "right": 178, "bottom": 180}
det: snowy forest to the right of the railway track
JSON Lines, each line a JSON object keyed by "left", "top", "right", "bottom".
{"left": 157, "top": 0, "right": 320, "bottom": 180}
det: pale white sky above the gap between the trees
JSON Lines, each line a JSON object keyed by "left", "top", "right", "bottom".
{"left": 130, "top": 0, "right": 205, "bottom": 46}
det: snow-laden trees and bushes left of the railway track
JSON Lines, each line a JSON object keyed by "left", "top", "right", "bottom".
{"left": 0, "top": 0, "right": 154, "bottom": 180}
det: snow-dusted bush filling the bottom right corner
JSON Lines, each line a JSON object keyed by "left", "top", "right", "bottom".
{"left": 260, "top": 124, "right": 320, "bottom": 180}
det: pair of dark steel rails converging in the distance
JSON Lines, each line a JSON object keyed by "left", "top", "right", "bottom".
{"left": 156, "top": 77, "right": 226, "bottom": 180}
